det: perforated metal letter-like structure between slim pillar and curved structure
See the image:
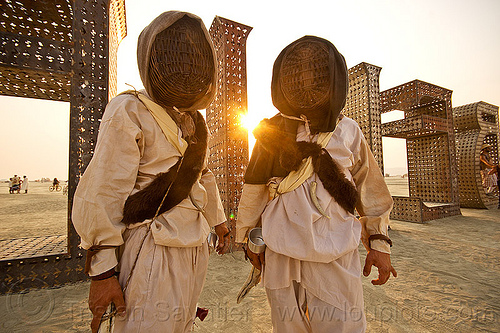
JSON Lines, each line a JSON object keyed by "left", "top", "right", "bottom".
{"left": 380, "top": 80, "right": 461, "bottom": 222}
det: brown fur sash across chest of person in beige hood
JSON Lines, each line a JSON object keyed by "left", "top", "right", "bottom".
{"left": 122, "top": 111, "right": 208, "bottom": 225}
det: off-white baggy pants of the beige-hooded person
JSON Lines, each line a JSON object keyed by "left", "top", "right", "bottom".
{"left": 114, "top": 226, "right": 209, "bottom": 333}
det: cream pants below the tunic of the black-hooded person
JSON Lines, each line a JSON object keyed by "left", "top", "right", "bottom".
{"left": 266, "top": 281, "right": 366, "bottom": 333}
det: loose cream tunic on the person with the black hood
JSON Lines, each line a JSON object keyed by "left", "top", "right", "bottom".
{"left": 236, "top": 117, "right": 392, "bottom": 322}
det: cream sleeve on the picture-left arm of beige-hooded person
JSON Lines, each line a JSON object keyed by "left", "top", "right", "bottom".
{"left": 72, "top": 97, "right": 143, "bottom": 276}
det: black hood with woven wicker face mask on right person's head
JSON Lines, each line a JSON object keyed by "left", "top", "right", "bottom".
{"left": 271, "top": 36, "right": 348, "bottom": 133}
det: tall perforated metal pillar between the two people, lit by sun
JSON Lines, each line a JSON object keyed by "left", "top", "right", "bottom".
{"left": 206, "top": 16, "right": 252, "bottom": 245}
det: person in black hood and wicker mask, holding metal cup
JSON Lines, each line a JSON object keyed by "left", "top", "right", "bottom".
{"left": 236, "top": 36, "right": 396, "bottom": 333}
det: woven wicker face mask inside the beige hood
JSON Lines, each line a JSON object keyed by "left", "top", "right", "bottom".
{"left": 149, "top": 17, "right": 215, "bottom": 108}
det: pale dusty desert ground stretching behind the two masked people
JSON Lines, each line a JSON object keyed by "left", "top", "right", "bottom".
{"left": 0, "top": 177, "right": 500, "bottom": 333}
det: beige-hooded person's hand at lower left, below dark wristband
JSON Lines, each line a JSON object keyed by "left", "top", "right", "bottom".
{"left": 89, "top": 276, "right": 126, "bottom": 333}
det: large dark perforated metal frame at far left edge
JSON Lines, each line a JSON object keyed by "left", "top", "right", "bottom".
{"left": 0, "top": 0, "right": 126, "bottom": 294}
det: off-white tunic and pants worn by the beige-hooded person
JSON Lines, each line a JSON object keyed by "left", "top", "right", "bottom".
{"left": 72, "top": 95, "right": 226, "bottom": 332}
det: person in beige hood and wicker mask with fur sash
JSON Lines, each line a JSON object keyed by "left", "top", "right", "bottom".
{"left": 72, "top": 11, "right": 229, "bottom": 332}
